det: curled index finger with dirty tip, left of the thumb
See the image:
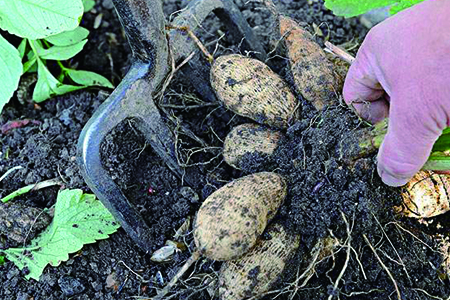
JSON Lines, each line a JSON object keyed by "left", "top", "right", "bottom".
{"left": 343, "top": 39, "right": 389, "bottom": 123}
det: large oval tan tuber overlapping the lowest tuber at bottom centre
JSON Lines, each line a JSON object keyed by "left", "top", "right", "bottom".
{"left": 194, "top": 172, "right": 287, "bottom": 261}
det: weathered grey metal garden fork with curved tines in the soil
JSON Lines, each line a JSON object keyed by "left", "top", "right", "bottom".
{"left": 78, "top": 0, "right": 264, "bottom": 251}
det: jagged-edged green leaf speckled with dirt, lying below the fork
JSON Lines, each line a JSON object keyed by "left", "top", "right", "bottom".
{"left": 0, "top": 190, "right": 119, "bottom": 280}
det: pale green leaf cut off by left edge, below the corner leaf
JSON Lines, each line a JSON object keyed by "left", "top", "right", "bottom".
{"left": 0, "top": 35, "right": 23, "bottom": 113}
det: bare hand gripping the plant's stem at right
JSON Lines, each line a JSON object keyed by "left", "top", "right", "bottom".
{"left": 343, "top": 0, "right": 450, "bottom": 186}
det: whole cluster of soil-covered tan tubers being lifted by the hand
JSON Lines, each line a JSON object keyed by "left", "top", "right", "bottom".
{"left": 156, "top": 0, "right": 450, "bottom": 300}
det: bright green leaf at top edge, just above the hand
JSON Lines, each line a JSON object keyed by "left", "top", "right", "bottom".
{"left": 325, "top": 0, "right": 423, "bottom": 18}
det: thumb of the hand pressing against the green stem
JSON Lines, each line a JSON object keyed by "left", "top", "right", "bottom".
{"left": 377, "top": 98, "right": 443, "bottom": 186}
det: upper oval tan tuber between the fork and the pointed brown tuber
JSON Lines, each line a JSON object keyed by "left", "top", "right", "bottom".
{"left": 211, "top": 54, "right": 299, "bottom": 128}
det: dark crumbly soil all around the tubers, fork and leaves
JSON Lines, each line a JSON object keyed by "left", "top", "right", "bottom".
{"left": 0, "top": 0, "right": 450, "bottom": 300}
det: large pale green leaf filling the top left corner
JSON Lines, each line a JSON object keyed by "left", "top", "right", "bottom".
{"left": 0, "top": 0, "right": 83, "bottom": 40}
